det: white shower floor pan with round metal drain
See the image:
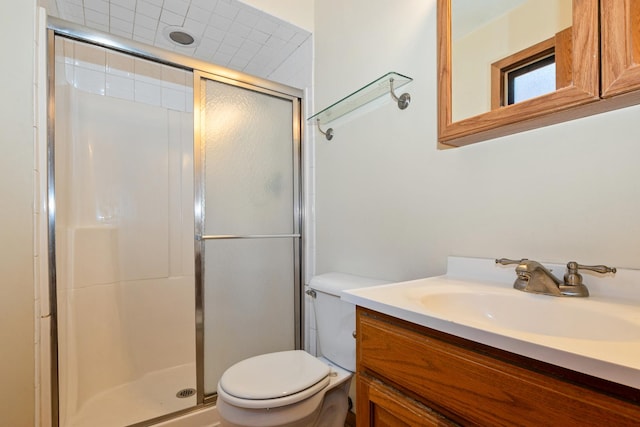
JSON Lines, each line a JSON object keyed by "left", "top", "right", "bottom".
{"left": 62, "top": 364, "right": 196, "bottom": 427}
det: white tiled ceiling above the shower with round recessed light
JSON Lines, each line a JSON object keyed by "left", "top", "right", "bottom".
{"left": 45, "top": 0, "right": 311, "bottom": 78}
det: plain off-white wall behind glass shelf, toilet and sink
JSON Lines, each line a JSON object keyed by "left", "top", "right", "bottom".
{"left": 314, "top": 0, "right": 640, "bottom": 280}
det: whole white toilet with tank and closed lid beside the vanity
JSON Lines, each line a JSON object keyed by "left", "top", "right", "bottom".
{"left": 217, "top": 273, "right": 387, "bottom": 427}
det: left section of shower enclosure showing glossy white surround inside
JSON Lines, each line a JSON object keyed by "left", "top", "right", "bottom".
{"left": 49, "top": 36, "right": 197, "bottom": 427}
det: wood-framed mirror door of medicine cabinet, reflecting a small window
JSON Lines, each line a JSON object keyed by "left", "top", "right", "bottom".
{"left": 438, "top": 0, "right": 599, "bottom": 146}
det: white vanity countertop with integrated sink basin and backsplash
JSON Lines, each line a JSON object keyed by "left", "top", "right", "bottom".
{"left": 342, "top": 257, "right": 640, "bottom": 389}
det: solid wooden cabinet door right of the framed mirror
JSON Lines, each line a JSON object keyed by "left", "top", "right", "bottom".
{"left": 600, "top": 0, "right": 640, "bottom": 98}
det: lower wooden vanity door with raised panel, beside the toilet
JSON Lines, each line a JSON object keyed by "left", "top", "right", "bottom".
{"left": 356, "top": 375, "right": 456, "bottom": 427}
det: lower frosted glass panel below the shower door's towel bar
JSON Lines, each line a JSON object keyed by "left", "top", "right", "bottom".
{"left": 204, "top": 239, "right": 295, "bottom": 394}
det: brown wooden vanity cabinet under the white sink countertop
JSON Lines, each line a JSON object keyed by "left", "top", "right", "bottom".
{"left": 356, "top": 307, "right": 640, "bottom": 427}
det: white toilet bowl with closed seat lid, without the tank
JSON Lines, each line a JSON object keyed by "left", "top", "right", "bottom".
{"left": 217, "top": 350, "right": 352, "bottom": 427}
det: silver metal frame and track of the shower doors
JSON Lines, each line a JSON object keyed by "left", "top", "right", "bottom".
{"left": 44, "top": 16, "right": 305, "bottom": 427}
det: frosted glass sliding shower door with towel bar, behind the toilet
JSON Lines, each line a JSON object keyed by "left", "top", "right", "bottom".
{"left": 194, "top": 75, "right": 301, "bottom": 396}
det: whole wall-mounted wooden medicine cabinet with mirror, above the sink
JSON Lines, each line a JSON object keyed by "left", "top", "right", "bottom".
{"left": 437, "top": 0, "right": 640, "bottom": 146}
